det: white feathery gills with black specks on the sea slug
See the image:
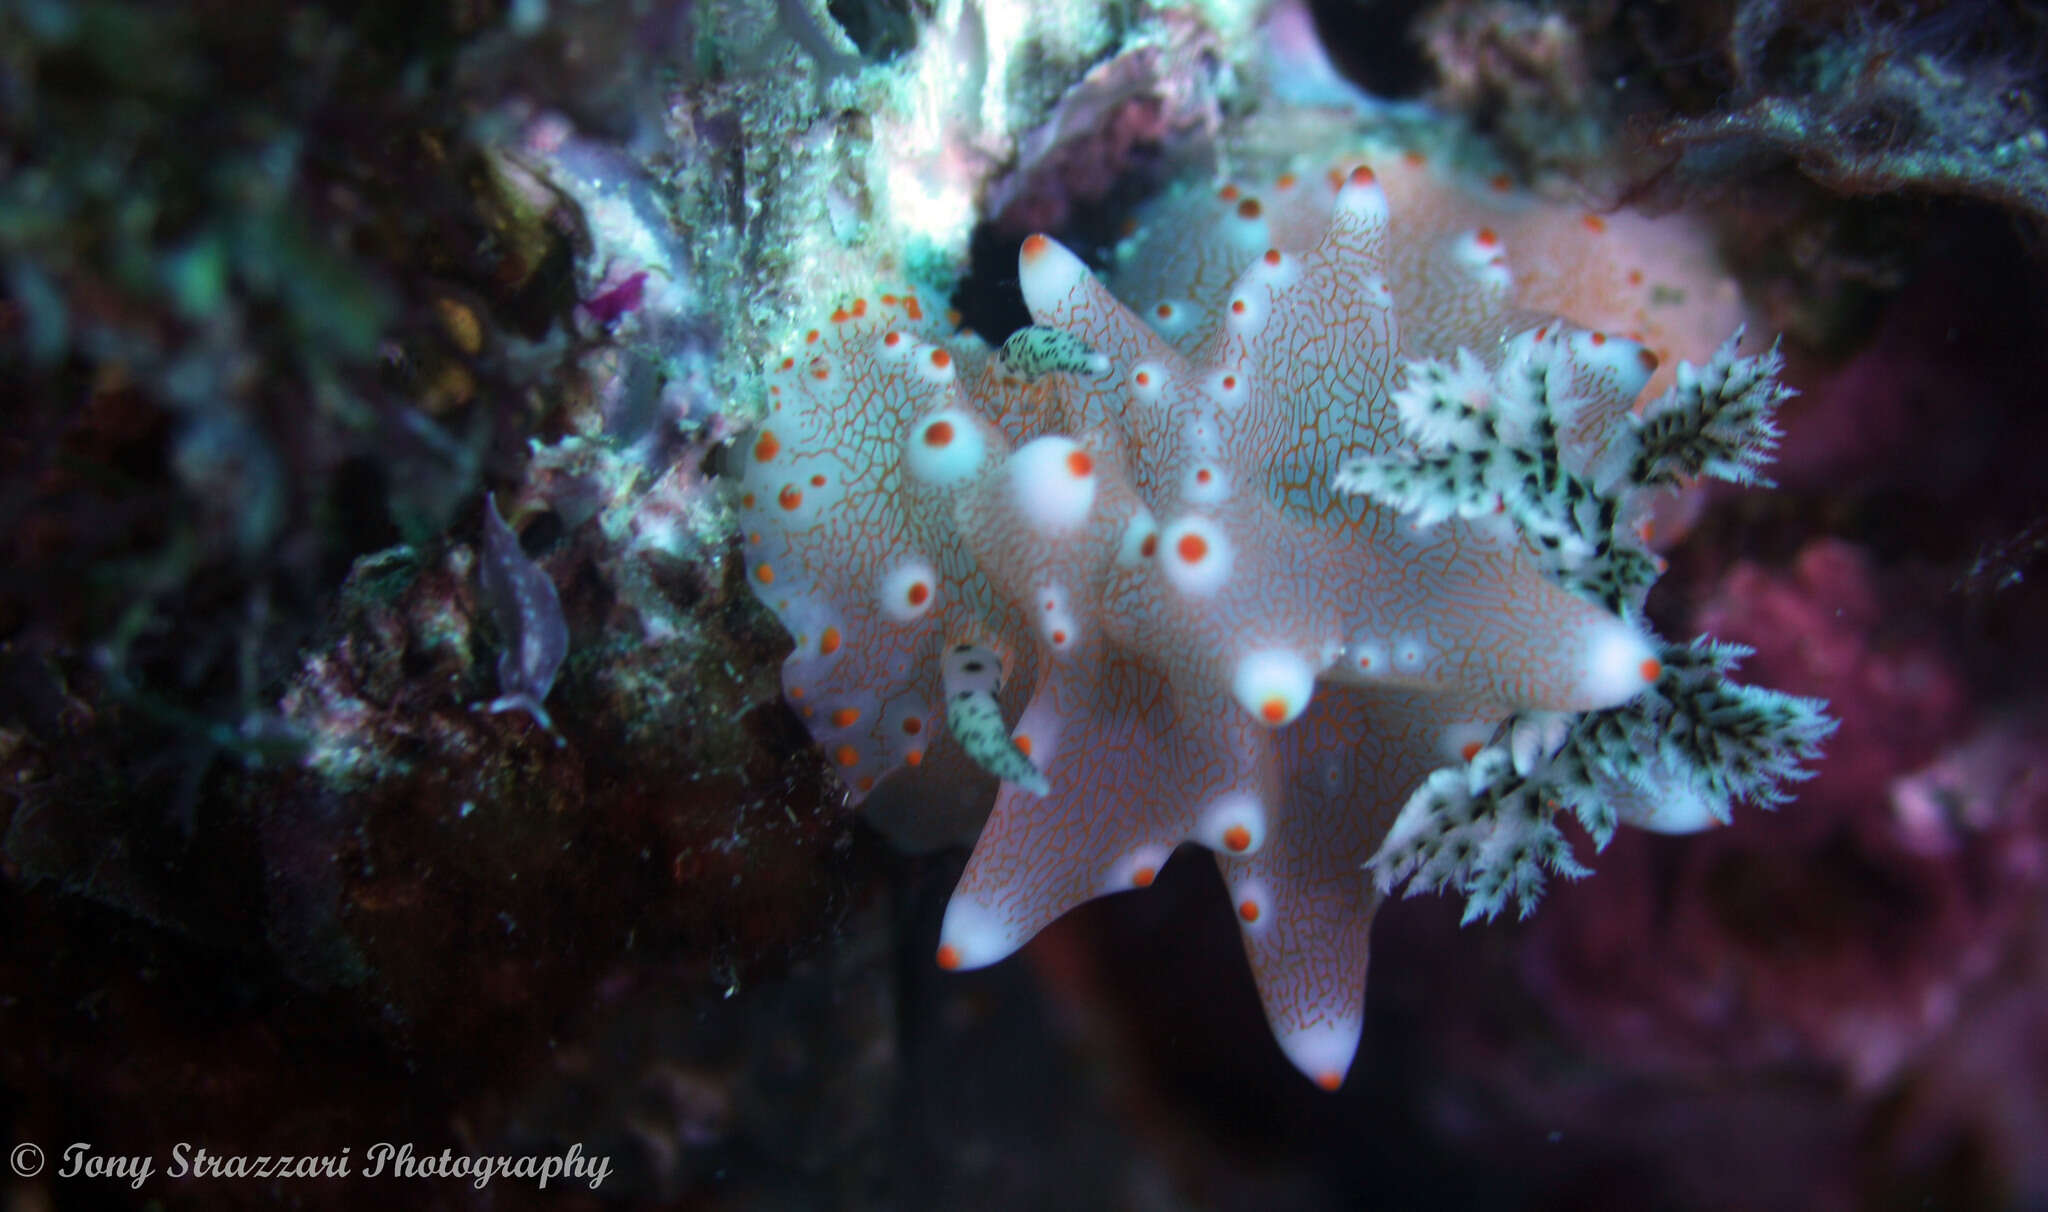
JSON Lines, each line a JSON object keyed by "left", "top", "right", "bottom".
{"left": 1335, "top": 332, "right": 1835, "bottom": 921}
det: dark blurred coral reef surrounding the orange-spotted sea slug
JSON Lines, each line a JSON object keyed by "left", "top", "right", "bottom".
{"left": 0, "top": 0, "right": 2048, "bottom": 1210}
